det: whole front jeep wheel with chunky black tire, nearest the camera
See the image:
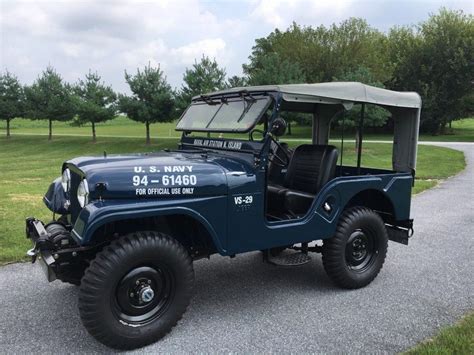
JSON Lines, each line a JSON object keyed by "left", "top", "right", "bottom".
{"left": 79, "top": 232, "right": 194, "bottom": 349}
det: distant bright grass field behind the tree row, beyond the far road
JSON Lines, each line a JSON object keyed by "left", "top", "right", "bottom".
{"left": 0, "top": 116, "right": 474, "bottom": 142}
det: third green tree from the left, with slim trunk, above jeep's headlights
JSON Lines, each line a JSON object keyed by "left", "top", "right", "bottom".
{"left": 74, "top": 71, "right": 117, "bottom": 142}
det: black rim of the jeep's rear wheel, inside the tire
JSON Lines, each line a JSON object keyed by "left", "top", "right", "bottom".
{"left": 346, "top": 229, "right": 377, "bottom": 272}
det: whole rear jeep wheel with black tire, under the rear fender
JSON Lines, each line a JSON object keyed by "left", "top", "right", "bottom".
{"left": 322, "top": 207, "right": 388, "bottom": 289}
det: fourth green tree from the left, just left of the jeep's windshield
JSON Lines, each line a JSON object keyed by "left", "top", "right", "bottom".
{"left": 119, "top": 64, "right": 174, "bottom": 144}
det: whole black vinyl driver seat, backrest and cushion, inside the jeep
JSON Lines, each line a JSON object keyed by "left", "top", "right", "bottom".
{"left": 268, "top": 144, "right": 338, "bottom": 218}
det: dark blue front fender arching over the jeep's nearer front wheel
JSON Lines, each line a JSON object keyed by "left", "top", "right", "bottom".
{"left": 72, "top": 196, "right": 227, "bottom": 254}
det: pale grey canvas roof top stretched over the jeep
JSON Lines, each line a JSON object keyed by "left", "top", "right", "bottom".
{"left": 201, "top": 82, "right": 421, "bottom": 109}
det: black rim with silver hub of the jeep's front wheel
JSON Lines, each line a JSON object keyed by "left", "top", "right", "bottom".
{"left": 113, "top": 266, "right": 175, "bottom": 326}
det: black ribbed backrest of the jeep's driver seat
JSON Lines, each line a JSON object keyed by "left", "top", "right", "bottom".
{"left": 284, "top": 144, "right": 338, "bottom": 195}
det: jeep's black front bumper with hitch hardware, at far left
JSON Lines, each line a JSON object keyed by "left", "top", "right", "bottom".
{"left": 25, "top": 217, "right": 57, "bottom": 282}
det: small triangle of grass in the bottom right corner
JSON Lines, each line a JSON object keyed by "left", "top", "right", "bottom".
{"left": 405, "top": 313, "right": 474, "bottom": 355}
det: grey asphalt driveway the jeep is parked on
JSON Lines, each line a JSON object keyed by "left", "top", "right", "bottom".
{"left": 0, "top": 143, "right": 474, "bottom": 353}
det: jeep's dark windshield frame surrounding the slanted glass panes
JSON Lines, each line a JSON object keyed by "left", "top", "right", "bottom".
{"left": 175, "top": 92, "right": 275, "bottom": 134}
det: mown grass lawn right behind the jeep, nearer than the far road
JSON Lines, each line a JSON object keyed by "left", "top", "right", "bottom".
{"left": 0, "top": 136, "right": 465, "bottom": 264}
